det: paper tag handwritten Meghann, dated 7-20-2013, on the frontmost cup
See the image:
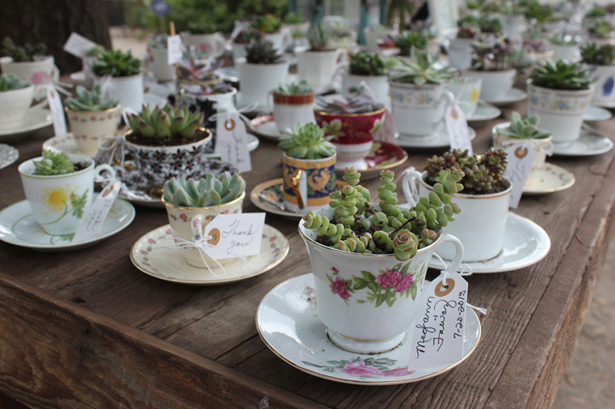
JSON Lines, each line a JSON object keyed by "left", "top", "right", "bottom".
{"left": 409, "top": 273, "right": 468, "bottom": 368}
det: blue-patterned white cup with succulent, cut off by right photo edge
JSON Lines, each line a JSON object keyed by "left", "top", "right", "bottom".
{"left": 581, "top": 43, "right": 615, "bottom": 105}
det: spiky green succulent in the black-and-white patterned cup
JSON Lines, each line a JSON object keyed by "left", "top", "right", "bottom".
{"left": 127, "top": 105, "right": 203, "bottom": 139}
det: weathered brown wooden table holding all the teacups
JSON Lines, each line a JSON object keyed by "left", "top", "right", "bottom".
{"left": 0, "top": 96, "right": 615, "bottom": 409}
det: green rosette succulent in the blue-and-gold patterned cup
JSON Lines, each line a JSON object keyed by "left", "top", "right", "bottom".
{"left": 278, "top": 123, "right": 335, "bottom": 159}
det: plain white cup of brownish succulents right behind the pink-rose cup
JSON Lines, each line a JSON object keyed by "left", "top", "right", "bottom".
{"left": 402, "top": 148, "right": 512, "bottom": 262}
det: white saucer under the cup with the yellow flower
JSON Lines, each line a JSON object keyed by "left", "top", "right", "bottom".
{"left": 0, "top": 194, "right": 135, "bottom": 252}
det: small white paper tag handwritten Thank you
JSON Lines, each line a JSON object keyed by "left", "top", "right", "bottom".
{"left": 205, "top": 213, "right": 265, "bottom": 260}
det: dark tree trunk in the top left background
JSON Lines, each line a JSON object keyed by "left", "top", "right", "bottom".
{"left": 0, "top": 0, "right": 111, "bottom": 74}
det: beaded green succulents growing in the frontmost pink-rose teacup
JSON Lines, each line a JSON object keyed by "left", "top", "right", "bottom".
{"left": 303, "top": 168, "right": 463, "bottom": 261}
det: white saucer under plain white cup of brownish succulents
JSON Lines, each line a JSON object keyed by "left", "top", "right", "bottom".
{"left": 429, "top": 212, "right": 551, "bottom": 273}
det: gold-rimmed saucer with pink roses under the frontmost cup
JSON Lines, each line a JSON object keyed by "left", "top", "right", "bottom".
{"left": 256, "top": 274, "right": 481, "bottom": 386}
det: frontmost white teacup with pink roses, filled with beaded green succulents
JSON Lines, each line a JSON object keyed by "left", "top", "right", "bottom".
{"left": 299, "top": 169, "right": 463, "bottom": 353}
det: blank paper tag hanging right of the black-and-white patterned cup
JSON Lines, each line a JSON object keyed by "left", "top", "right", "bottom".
{"left": 216, "top": 112, "right": 252, "bottom": 173}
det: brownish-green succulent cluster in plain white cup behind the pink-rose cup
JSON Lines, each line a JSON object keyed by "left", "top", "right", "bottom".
{"left": 425, "top": 148, "right": 509, "bottom": 195}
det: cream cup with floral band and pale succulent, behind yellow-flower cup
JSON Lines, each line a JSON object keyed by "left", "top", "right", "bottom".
{"left": 65, "top": 85, "right": 122, "bottom": 156}
